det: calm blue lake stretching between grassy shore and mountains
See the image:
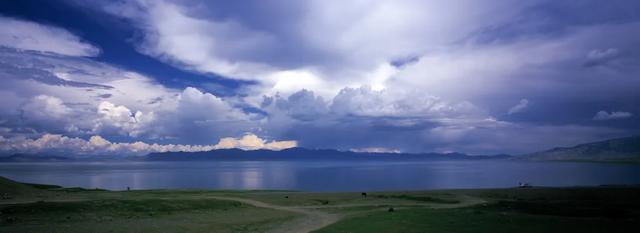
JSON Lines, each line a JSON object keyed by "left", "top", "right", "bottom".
{"left": 0, "top": 160, "right": 640, "bottom": 192}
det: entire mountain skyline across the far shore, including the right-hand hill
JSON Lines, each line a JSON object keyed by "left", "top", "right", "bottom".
{"left": 0, "top": 136, "right": 640, "bottom": 163}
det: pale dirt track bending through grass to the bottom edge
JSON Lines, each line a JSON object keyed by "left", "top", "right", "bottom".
{"left": 212, "top": 197, "right": 343, "bottom": 233}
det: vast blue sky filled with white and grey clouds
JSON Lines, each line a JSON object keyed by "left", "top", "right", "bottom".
{"left": 0, "top": 0, "right": 640, "bottom": 157}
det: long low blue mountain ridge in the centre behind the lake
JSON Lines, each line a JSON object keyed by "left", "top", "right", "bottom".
{"left": 146, "top": 148, "right": 510, "bottom": 161}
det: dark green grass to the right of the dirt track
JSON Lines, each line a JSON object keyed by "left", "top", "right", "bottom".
{"left": 316, "top": 188, "right": 640, "bottom": 233}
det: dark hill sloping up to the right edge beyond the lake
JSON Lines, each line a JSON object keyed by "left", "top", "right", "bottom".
{"left": 520, "top": 136, "right": 640, "bottom": 162}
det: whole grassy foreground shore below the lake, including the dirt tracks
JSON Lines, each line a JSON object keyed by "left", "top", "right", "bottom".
{"left": 0, "top": 177, "right": 640, "bottom": 233}
